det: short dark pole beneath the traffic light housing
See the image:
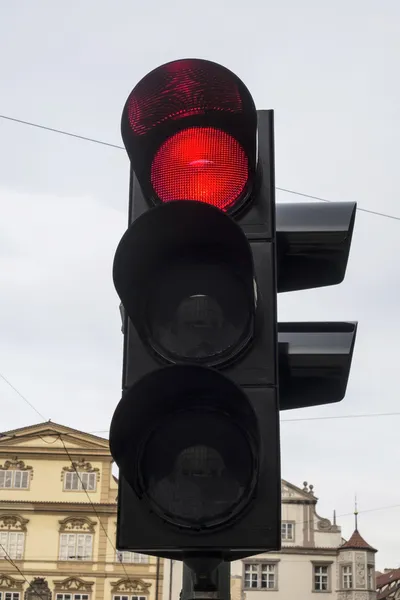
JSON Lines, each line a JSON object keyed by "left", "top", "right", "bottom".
{"left": 180, "top": 559, "right": 231, "bottom": 600}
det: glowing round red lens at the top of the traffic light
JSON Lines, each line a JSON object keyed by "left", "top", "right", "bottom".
{"left": 151, "top": 127, "right": 249, "bottom": 210}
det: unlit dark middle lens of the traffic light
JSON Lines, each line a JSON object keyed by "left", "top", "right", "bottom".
{"left": 147, "top": 263, "right": 251, "bottom": 362}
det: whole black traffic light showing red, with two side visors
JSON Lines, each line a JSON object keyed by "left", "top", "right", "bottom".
{"left": 110, "top": 59, "right": 356, "bottom": 562}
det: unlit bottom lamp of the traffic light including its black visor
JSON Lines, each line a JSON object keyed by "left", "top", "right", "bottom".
{"left": 110, "top": 366, "right": 259, "bottom": 530}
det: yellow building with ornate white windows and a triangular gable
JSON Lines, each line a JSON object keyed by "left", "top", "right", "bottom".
{"left": 0, "top": 421, "right": 163, "bottom": 600}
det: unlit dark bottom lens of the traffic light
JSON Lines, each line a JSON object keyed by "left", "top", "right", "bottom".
{"left": 141, "top": 409, "right": 255, "bottom": 528}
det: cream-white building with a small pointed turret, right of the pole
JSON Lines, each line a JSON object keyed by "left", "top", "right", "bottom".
{"left": 163, "top": 480, "right": 376, "bottom": 600}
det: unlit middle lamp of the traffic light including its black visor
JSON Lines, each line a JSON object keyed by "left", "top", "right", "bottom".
{"left": 113, "top": 201, "right": 256, "bottom": 366}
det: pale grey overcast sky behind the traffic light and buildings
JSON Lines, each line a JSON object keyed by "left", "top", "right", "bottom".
{"left": 0, "top": 0, "right": 400, "bottom": 568}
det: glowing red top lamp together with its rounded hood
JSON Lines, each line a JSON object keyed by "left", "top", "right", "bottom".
{"left": 121, "top": 59, "right": 257, "bottom": 212}
